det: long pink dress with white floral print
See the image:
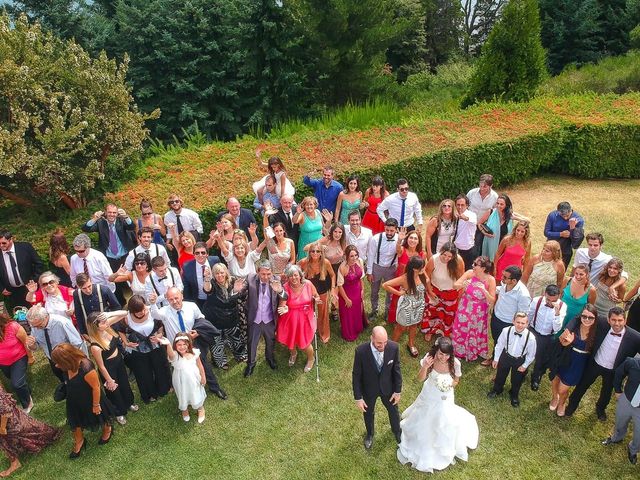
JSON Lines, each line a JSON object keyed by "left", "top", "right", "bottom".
{"left": 451, "top": 276, "right": 489, "bottom": 362}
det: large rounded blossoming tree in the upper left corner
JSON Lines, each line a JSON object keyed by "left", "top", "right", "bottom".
{"left": 0, "top": 14, "right": 157, "bottom": 209}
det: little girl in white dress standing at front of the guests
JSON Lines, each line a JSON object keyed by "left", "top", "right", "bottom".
{"left": 160, "top": 332, "right": 207, "bottom": 423}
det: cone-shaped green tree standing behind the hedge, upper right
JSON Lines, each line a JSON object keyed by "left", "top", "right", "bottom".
{"left": 463, "top": 0, "right": 546, "bottom": 106}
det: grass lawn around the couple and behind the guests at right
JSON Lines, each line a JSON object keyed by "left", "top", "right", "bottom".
{"left": 6, "top": 177, "right": 640, "bottom": 480}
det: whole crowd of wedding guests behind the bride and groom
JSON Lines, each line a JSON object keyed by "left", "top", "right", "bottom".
{"left": 0, "top": 166, "right": 640, "bottom": 476}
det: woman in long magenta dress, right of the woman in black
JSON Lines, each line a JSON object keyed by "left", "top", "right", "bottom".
{"left": 338, "top": 245, "right": 367, "bottom": 342}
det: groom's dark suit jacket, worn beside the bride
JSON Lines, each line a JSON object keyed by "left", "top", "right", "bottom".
{"left": 351, "top": 341, "right": 402, "bottom": 403}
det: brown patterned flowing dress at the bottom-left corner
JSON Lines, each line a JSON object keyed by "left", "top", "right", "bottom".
{"left": 0, "top": 384, "right": 62, "bottom": 478}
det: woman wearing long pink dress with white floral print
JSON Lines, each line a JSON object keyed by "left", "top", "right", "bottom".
{"left": 451, "top": 257, "right": 496, "bottom": 362}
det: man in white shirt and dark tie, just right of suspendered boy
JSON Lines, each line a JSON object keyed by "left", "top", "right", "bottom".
{"left": 528, "top": 285, "right": 567, "bottom": 392}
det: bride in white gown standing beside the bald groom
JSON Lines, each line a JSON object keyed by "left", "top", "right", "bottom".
{"left": 398, "top": 337, "right": 478, "bottom": 473}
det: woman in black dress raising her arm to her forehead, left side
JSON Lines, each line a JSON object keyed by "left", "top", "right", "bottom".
{"left": 87, "top": 310, "right": 138, "bottom": 425}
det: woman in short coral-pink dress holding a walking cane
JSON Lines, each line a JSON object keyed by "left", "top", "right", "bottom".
{"left": 276, "top": 265, "right": 320, "bottom": 373}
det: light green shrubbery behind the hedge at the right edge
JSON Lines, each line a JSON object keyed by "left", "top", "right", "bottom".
{"left": 538, "top": 51, "right": 640, "bottom": 96}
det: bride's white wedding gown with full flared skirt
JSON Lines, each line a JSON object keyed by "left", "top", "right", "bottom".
{"left": 398, "top": 359, "right": 479, "bottom": 473}
